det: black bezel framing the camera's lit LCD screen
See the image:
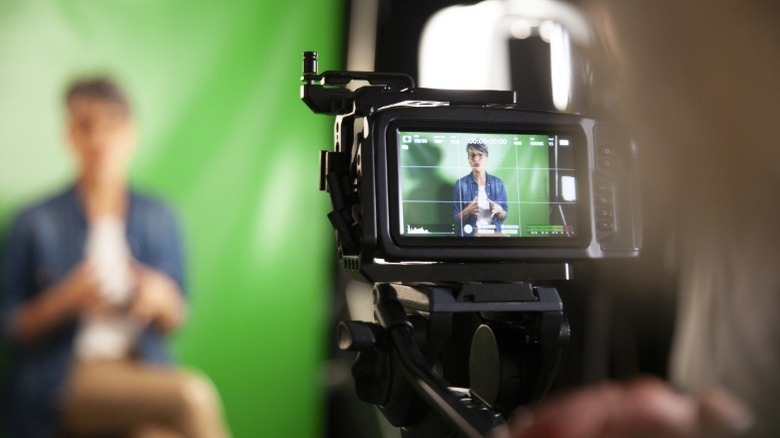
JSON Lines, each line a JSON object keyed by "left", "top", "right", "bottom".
{"left": 373, "top": 107, "right": 593, "bottom": 261}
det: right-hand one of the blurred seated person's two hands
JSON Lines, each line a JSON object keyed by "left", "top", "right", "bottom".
{"left": 130, "top": 263, "right": 185, "bottom": 331}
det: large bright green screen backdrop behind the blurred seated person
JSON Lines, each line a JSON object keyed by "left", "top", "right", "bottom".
{"left": 0, "top": 0, "right": 343, "bottom": 437}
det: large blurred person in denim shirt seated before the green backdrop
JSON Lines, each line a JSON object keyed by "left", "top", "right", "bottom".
{"left": 0, "top": 78, "right": 226, "bottom": 437}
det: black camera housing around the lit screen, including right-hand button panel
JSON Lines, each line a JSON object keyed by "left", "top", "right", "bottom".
{"left": 340, "top": 103, "right": 641, "bottom": 281}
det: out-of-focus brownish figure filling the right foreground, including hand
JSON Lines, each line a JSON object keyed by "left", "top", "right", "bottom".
{"left": 513, "top": 0, "right": 780, "bottom": 438}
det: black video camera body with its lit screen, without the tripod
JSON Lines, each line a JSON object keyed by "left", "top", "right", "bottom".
{"left": 304, "top": 63, "right": 641, "bottom": 282}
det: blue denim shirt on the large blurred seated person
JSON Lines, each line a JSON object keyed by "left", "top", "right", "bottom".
{"left": 0, "top": 187, "right": 184, "bottom": 437}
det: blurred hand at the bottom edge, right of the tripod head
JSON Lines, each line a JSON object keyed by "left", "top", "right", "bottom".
{"left": 502, "top": 378, "right": 752, "bottom": 438}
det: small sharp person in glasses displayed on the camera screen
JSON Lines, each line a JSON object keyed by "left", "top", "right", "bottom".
{"left": 453, "top": 143, "right": 509, "bottom": 236}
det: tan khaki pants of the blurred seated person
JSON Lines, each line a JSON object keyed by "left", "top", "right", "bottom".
{"left": 62, "top": 360, "right": 227, "bottom": 438}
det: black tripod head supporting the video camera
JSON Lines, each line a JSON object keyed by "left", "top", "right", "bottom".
{"left": 338, "top": 282, "right": 569, "bottom": 437}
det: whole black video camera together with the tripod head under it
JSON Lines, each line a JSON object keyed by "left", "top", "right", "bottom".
{"left": 301, "top": 52, "right": 641, "bottom": 437}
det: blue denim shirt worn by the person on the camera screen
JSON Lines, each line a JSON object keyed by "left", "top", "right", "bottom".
{"left": 452, "top": 173, "right": 509, "bottom": 236}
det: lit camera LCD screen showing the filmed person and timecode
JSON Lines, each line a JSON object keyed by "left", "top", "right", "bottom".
{"left": 394, "top": 127, "right": 585, "bottom": 241}
